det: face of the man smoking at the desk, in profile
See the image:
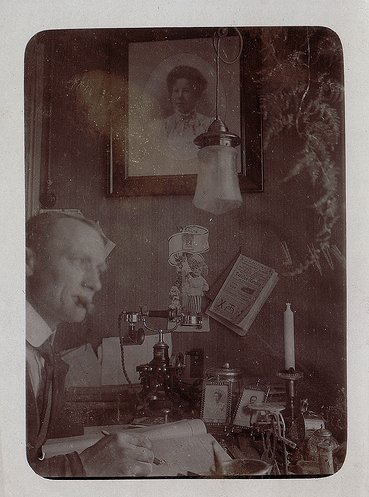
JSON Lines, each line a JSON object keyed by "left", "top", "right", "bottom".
{"left": 27, "top": 219, "right": 105, "bottom": 328}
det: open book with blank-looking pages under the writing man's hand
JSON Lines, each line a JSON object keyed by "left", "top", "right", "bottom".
{"left": 43, "top": 419, "right": 231, "bottom": 477}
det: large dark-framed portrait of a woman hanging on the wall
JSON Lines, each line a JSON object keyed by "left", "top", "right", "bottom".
{"left": 107, "top": 28, "right": 263, "bottom": 196}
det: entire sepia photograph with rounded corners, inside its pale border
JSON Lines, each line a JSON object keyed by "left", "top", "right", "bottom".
{"left": 24, "top": 26, "right": 348, "bottom": 479}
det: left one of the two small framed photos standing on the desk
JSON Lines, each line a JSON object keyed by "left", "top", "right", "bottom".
{"left": 201, "top": 381, "right": 231, "bottom": 425}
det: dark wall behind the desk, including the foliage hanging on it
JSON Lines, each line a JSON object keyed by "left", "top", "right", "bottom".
{"left": 28, "top": 28, "right": 346, "bottom": 418}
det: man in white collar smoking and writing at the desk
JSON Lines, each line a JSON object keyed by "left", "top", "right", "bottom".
{"left": 26, "top": 212, "right": 153, "bottom": 477}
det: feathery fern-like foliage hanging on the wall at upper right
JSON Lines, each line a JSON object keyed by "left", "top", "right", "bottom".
{"left": 259, "top": 28, "right": 344, "bottom": 276}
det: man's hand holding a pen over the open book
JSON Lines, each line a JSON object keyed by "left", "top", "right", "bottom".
{"left": 80, "top": 433, "right": 154, "bottom": 476}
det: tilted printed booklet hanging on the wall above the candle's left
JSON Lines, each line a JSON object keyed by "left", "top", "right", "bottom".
{"left": 206, "top": 254, "right": 278, "bottom": 336}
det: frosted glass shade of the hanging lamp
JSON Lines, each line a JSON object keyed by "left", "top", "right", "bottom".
{"left": 192, "top": 145, "right": 242, "bottom": 214}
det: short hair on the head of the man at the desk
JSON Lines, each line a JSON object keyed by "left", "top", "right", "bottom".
{"left": 26, "top": 211, "right": 105, "bottom": 251}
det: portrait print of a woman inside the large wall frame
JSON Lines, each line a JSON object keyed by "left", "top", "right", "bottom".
{"left": 127, "top": 38, "right": 240, "bottom": 176}
